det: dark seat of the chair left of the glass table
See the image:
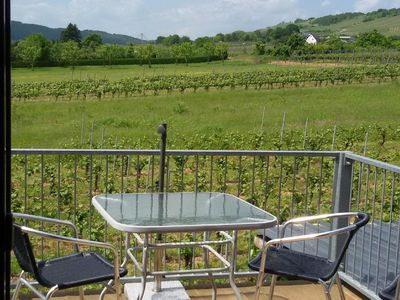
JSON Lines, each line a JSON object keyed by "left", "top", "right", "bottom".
{"left": 38, "top": 252, "right": 127, "bottom": 290}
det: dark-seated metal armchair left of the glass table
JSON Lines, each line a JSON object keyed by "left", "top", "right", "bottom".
{"left": 12, "top": 213, "right": 127, "bottom": 300}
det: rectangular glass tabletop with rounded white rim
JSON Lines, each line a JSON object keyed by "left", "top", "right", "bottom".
{"left": 93, "top": 192, "right": 276, "bottom": 232}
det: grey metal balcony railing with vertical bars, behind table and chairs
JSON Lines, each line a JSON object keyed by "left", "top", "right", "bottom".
{"left": 12, "top": 149, "right": 400, "bottom": 298}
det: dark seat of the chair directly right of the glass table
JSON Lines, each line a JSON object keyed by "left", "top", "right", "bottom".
{"left": 249, "top": 247, "right": 334, "bottom": 282}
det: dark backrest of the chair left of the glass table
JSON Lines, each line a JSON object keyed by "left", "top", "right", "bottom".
{"left": 13, "top": 223, "right": 39, "bottom": 278}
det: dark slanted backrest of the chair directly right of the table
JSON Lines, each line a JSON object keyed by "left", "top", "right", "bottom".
{"left": 327, "top": 212, "right": 369, "bottom": 277}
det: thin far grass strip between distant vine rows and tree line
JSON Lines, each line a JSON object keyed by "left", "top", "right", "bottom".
{"left": 11, "top": 55, "right": 316, "bottom": 82}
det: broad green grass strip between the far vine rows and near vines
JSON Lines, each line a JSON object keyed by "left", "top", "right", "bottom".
{"left": 12, "top": 82, "right": 400, "bottom": 148}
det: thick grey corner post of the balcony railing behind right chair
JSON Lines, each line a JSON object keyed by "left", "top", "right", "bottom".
{"left": 330, "top": 152, "right": 353, "bottom": 264}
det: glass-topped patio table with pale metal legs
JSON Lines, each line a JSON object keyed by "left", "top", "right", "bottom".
{"left": 92, "top": 192, "right": 277, "bottom": 299}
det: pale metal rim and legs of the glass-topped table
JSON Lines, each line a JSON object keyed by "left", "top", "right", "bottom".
{"left": 92, "top": 193, "right": 277, "bottom": 300}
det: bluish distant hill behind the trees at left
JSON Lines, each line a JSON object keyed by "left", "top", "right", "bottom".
{"left": 11, "top": 21, "right": 143, "bottom": 45}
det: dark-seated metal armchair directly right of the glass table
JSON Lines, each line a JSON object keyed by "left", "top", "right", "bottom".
{"left": 249, "top": 212, "right": 369, "bottom": 300}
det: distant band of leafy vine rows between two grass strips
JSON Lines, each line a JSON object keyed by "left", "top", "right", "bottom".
{"left": 12, "top": 64, "right": 400, "bottom": 100}
